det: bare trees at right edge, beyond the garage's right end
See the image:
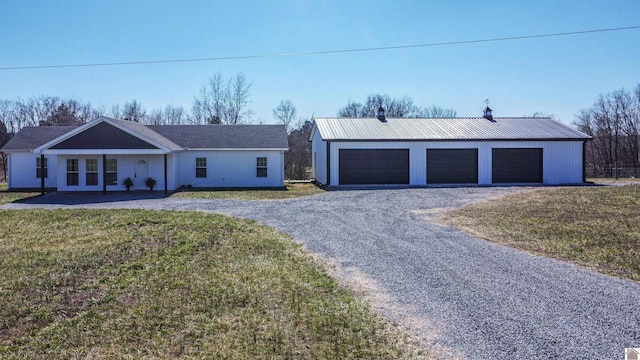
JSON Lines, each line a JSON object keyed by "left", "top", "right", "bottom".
{"left": 574, "top": 84, "right": 640, "bottom": 177}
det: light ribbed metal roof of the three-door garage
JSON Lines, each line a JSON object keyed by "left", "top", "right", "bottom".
{"left": 315, "top": 117, "right": 591, "bottom": 141}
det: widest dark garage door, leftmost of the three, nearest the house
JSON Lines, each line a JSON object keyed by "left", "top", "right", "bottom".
{"left": 339, "top": 149, "right": 409, "bottom": 185}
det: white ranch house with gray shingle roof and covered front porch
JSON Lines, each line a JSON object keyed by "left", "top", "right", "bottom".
{"left": 2, "top": 117, "right": 288, "bottom": 192}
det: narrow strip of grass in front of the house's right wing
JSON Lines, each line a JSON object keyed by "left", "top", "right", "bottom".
{"left": 172, "top": 183, "right": 324, "bottom": 200}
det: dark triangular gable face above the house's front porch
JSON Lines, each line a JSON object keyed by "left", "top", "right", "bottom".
{"left": 49, "top": 122, "right": 158, "bottom": 150}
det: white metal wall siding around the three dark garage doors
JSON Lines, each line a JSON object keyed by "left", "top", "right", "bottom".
{"left": 328, "top": 141, "right": 583, "bottom": 186}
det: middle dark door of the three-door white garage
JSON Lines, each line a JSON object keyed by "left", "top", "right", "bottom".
{"left": 427, "top": 149, "right": 478, "bottom": 184}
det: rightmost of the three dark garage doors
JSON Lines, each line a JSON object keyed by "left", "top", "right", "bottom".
{"left": 492, "top": 149, "right": 542, "bottom": 184}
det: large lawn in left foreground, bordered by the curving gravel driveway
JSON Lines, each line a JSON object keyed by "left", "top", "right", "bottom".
{"left": 0, "top": 209, "right": 423, "bottom": 359}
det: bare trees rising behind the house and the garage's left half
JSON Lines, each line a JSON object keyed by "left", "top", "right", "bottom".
{"left": 0, "top": 73, "right": 456, "bottom": 182}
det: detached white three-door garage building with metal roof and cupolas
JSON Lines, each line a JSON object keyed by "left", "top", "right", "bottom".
{"left": 309, "top": 108, "right": 591, "bottom": 186}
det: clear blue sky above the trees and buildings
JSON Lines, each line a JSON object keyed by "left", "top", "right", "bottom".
{"left": 0, "top": 0, "right": 640, "bottom": 123}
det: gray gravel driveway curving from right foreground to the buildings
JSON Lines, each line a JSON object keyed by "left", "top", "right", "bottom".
{"left": 2, "top": 187, "right": 640, "bottom": 359}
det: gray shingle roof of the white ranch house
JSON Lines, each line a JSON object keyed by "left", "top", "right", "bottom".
{"left": 2, "top": 117, "right": 289, "bottom": 151}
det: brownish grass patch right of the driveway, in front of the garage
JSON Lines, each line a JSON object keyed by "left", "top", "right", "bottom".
{"left": 445, "top": 185, "right": 640, "bottom": 281}
